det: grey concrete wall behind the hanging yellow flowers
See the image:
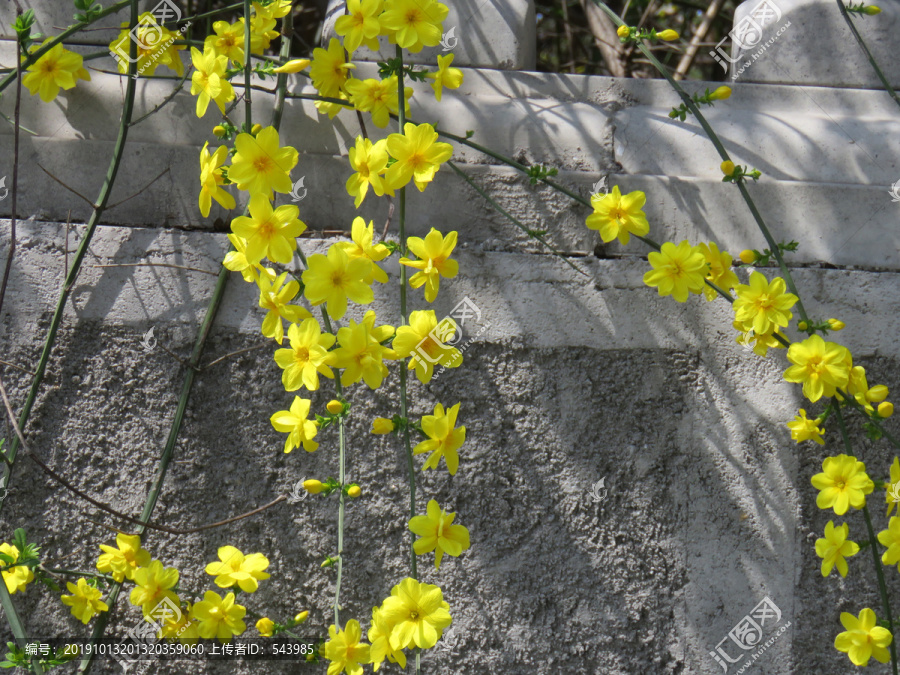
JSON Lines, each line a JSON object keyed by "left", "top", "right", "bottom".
{"left": 0, "top": 1, "right": 900, "bottom": 675}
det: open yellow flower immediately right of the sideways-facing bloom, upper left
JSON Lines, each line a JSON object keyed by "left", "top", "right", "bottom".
{"left": 228, "top": 127, "right": 299, "bottom": 197}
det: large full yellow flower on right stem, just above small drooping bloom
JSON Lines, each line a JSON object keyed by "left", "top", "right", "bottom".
{"left": 784, "top": 335, "right": 853, "bottom": 403}
